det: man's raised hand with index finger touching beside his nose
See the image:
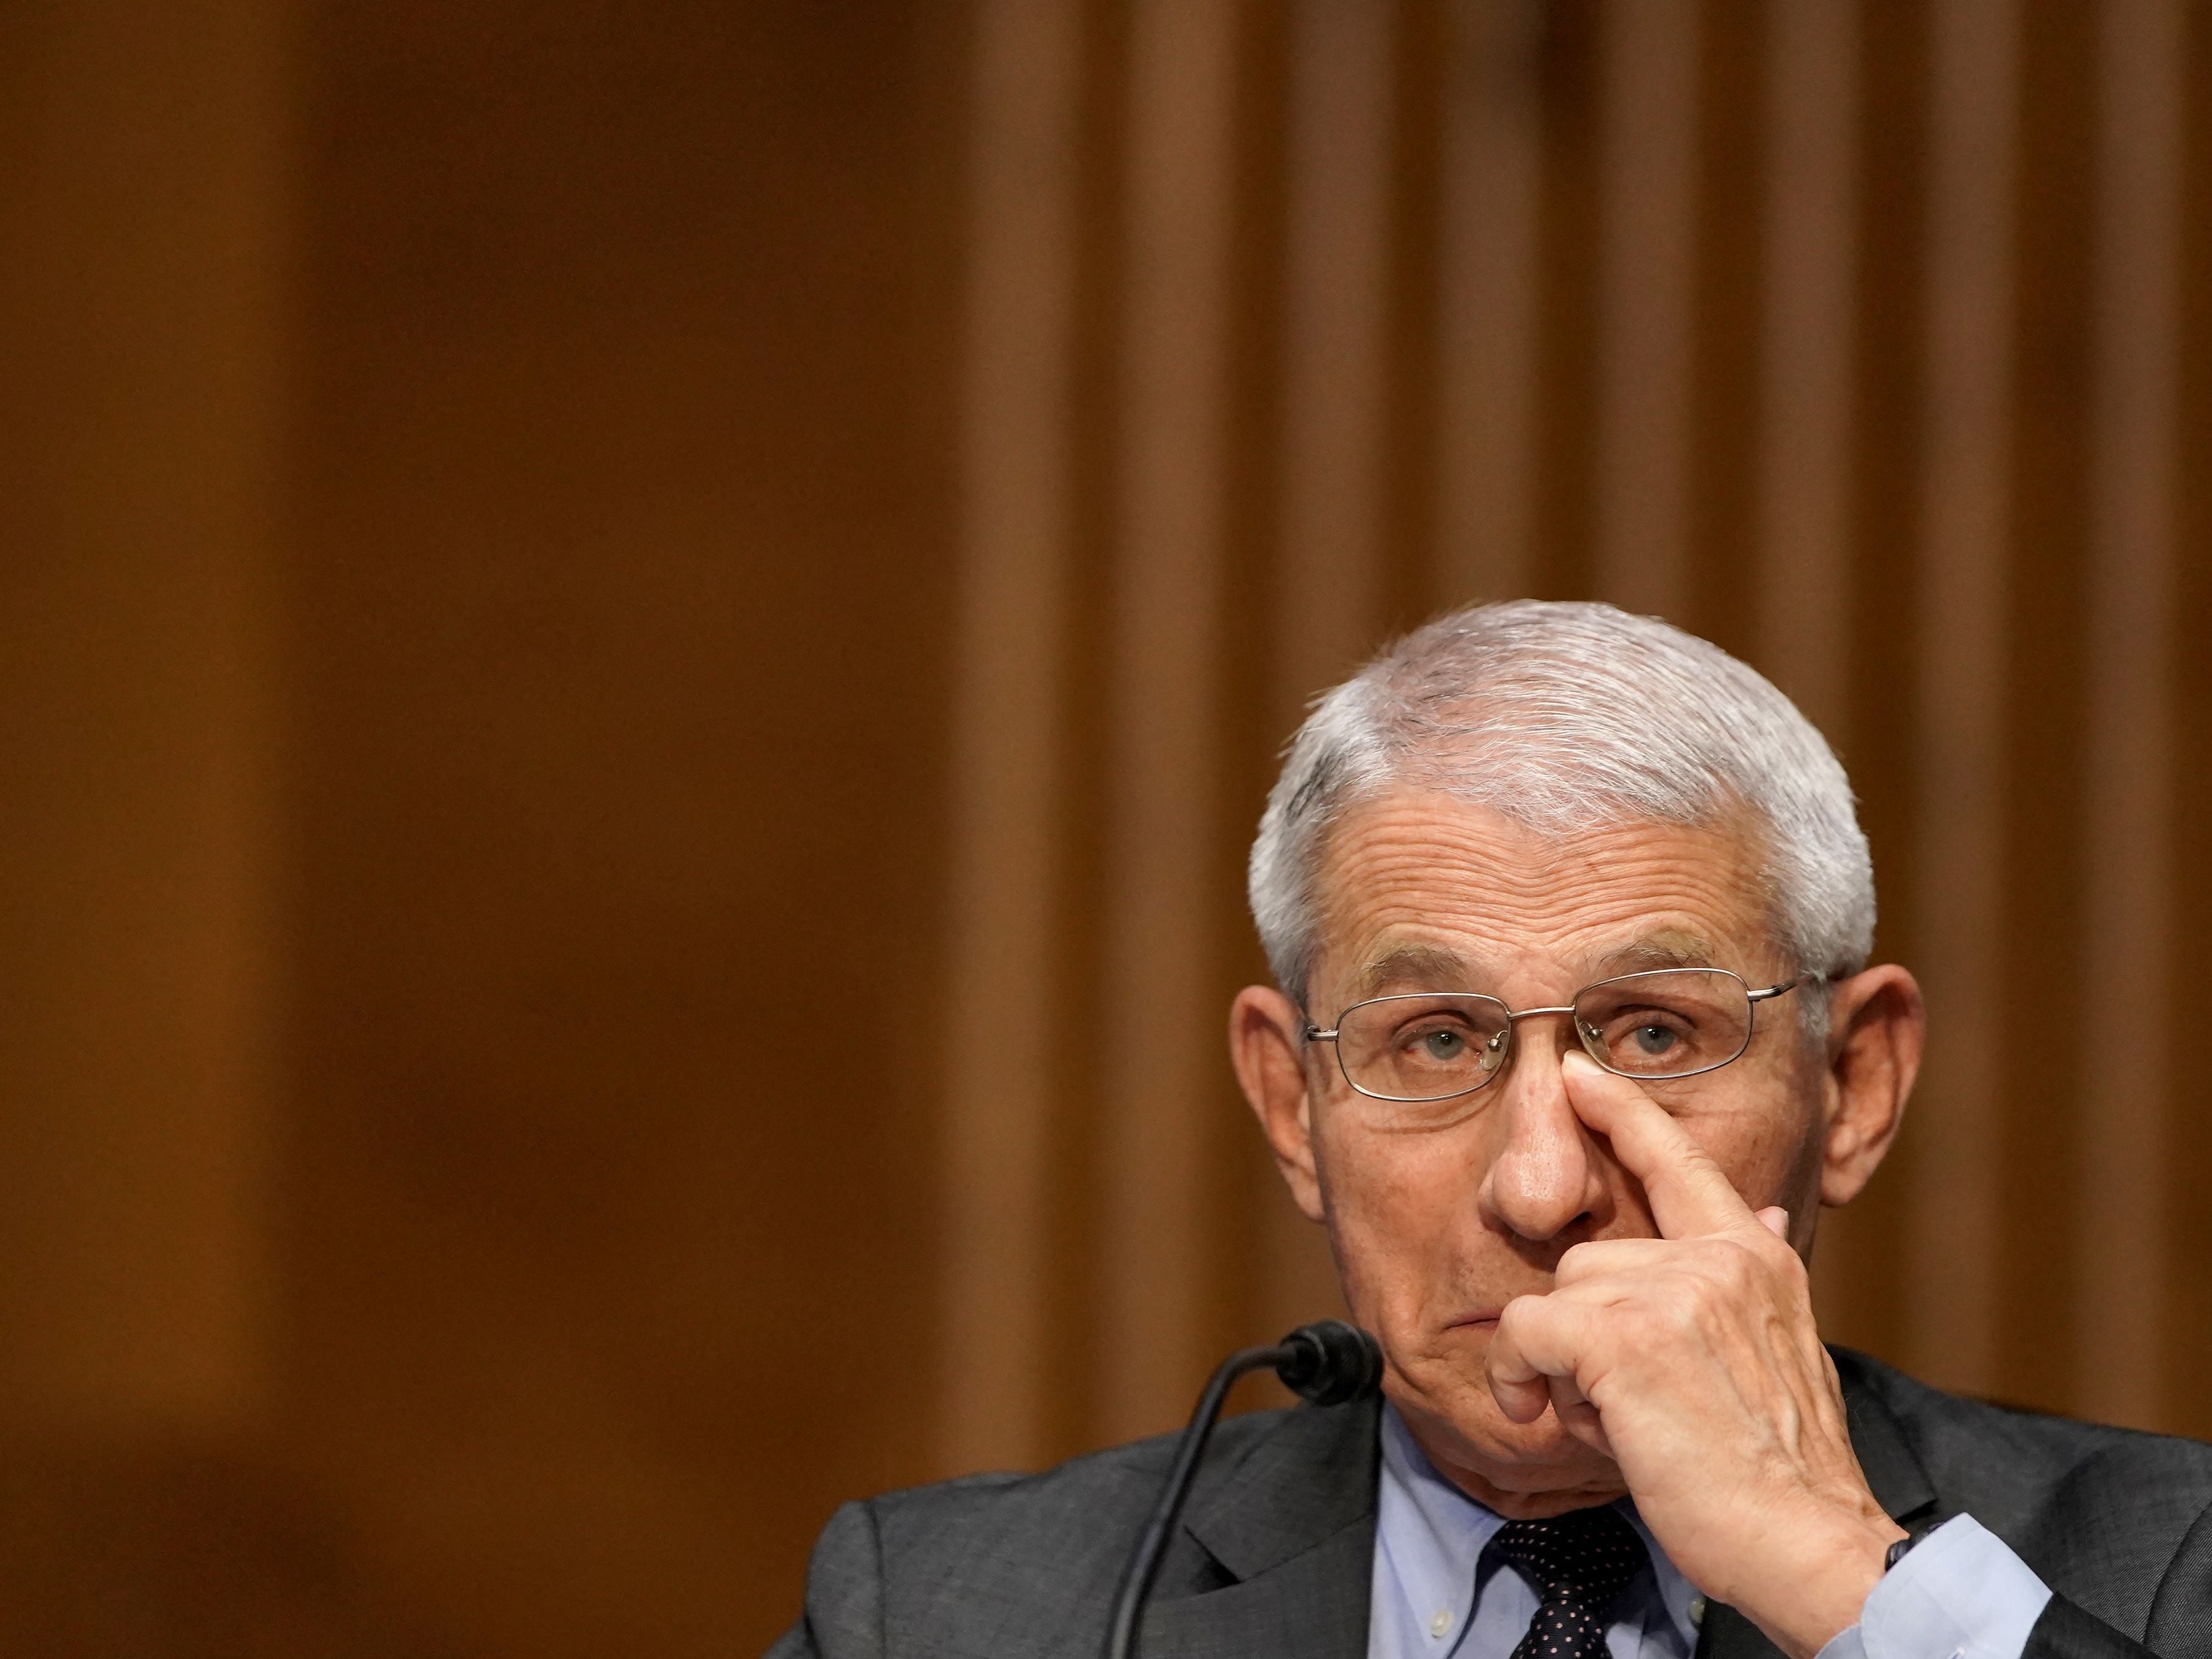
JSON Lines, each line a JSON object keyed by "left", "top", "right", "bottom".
{"left": 1487, "top": 1053, "right": 1905, "bottom": 1659}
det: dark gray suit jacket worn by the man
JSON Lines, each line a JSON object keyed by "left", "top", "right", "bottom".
{"left": 769, "top": 1349, "right": 2212, "bottom": 1659}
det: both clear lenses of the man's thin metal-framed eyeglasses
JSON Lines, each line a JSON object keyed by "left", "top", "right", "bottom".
{"left": 1336, "top": 969, "right": 1752, "bottom": 1099}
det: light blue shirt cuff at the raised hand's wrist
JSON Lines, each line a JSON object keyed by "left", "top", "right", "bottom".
{"left": 1818, "top": 1515, "right": 2050, "bottom": 1659}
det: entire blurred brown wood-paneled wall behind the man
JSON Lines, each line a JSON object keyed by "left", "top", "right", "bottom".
{"left": 0, "top": 0, "right": 2212, "bottom": 1657}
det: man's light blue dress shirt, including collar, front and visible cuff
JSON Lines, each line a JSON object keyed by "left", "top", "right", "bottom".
{"left": 1367, "top": 1405, "right": 2050, "bottom": 1659}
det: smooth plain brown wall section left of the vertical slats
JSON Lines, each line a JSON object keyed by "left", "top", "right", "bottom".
{"left": 0, "top": 0, "right": 964, "bottom": 1659}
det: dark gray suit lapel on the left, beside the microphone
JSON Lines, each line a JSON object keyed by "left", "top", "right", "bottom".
{"left": 1137, "top": 1403, "right": 1380, "bottom": 1659}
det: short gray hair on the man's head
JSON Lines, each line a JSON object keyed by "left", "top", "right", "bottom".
{"left": 1250, "top": 600, "right": 1874, "bottom": 1018}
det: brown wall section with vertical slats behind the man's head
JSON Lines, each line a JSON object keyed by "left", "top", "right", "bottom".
{"left": 940, "top": 0, "right": 2212, "bottom": 1467}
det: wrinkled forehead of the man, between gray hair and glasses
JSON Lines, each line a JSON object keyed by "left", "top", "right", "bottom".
{"left": 1314, "top": 789, "right": 1785, "bottom": 1000}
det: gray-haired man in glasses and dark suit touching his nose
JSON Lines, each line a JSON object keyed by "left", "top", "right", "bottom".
{"left": 776, "top": 604, "right": 2212, "bottom": 1659}
